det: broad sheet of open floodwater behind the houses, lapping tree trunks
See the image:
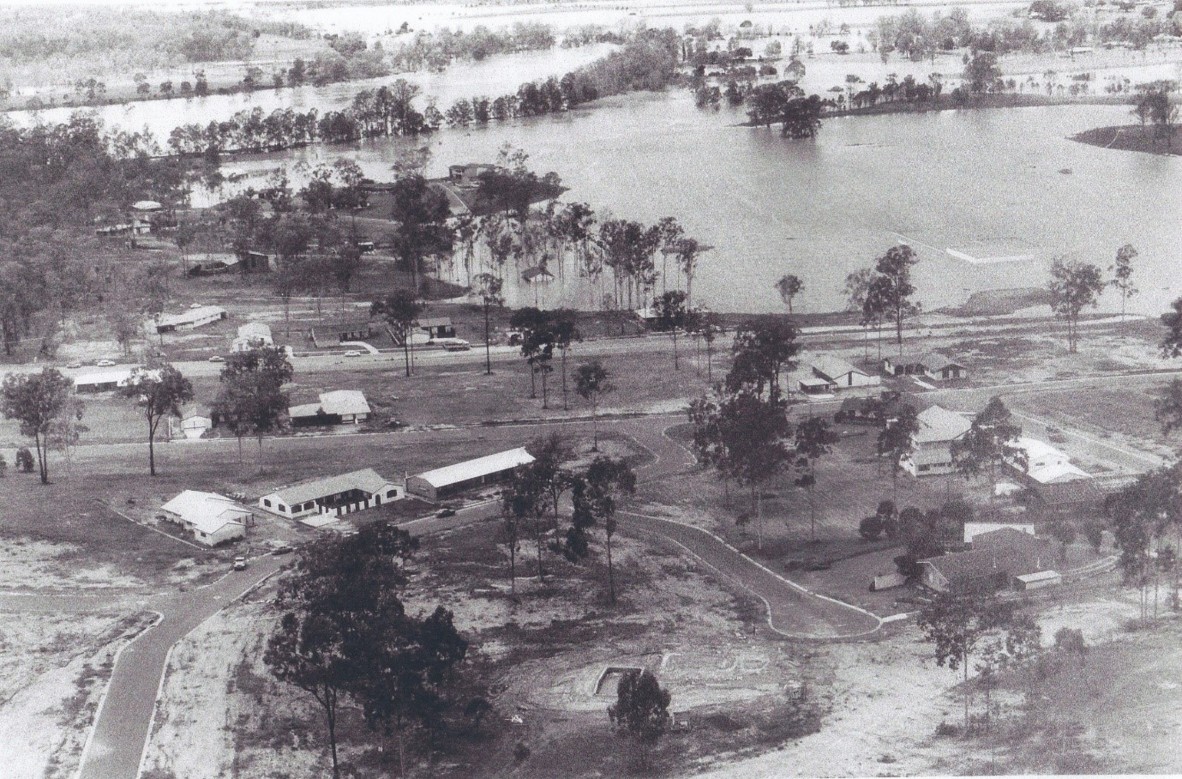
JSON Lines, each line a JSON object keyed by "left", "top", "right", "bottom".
{"left": 208, "top": 91, "right": 1182, "bottom": 313}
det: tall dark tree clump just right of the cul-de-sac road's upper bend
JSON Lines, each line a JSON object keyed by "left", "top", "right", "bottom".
{"left": 688, "top": 320, "right": 838, "bottom": 546}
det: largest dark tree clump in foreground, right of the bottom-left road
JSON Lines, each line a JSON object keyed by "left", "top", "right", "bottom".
{"left": 262, "top": 522, "right": 472, "bottom": 777}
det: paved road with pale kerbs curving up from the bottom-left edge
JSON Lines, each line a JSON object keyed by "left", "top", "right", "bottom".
{"left": 78, "top": 557, "right": 287, "bottom": 779}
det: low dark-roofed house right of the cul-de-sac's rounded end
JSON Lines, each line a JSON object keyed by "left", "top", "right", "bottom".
{"left": 918, "top": 527, "right": 1054, "bottom": 592}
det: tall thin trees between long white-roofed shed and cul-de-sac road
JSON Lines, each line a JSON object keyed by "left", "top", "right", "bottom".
{"left": 501, "top": 435, "right": 636, "bottom": 603}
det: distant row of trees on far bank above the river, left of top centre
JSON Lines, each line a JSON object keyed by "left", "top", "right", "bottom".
{"left": 390, "top": 21, "right": 554, "bottom": 73}
